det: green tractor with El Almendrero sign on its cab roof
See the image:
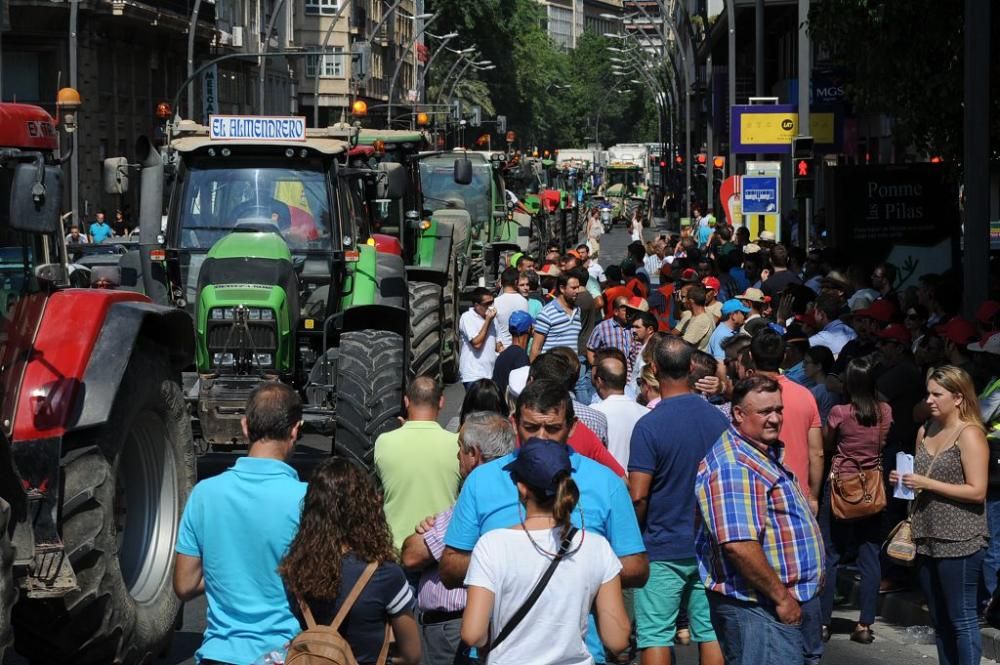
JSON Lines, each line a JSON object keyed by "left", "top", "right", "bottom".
{"left": 105, "top": 116, "right": 434, "bottom": 468}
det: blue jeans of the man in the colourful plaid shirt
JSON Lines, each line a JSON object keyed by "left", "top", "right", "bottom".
{"left": 708, "top": 591, "right": 822, "bottom": 665}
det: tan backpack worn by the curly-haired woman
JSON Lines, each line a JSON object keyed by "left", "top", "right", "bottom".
{"left": 285, "top": 563, "right": 389, "bottom": 665}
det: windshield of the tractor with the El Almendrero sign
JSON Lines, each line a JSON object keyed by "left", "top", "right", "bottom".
{"left": 175, "top": 160, "right": 332, "bottom": 252}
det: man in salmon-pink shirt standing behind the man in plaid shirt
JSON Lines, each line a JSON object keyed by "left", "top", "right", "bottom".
{"left": 750, "top": 328, "right": 823, "bottom": 514}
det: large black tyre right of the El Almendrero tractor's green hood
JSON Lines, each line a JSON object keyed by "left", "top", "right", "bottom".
{"left": 333, "top": 330, "right": 406, "bottom": 470}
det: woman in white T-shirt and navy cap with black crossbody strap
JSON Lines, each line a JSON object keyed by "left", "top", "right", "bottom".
{"left": 462, "top": 439, "right": 630, "bottom": 665}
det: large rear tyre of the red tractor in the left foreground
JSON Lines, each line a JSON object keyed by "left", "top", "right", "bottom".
{"left": 14, "top": 344, "right": 196, "bottom": 665}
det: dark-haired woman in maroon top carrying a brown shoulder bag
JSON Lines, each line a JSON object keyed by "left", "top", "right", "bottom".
{"left": 821, "top": 356, "right": 892, "bottom": 644}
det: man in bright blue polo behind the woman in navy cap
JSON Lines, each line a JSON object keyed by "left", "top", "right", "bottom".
{"left": 439, "top": 381, "right": 649, "bottom": 663}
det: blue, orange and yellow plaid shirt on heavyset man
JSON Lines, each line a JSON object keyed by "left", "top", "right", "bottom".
{"left": 695, "top": 427, "right": 825, "bottom": 604}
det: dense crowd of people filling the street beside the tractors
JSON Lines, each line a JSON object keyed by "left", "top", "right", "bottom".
{"left": 175, "top": 215, "right": 1000, "bottom": 665}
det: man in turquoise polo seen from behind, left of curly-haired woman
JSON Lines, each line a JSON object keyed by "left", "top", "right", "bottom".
{"left": 174, "top": 383, "right": 306, "bottom": 665}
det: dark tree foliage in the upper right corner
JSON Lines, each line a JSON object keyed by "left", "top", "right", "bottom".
{"left": 809, "top": 0, "right": 1000, "bottom": 159}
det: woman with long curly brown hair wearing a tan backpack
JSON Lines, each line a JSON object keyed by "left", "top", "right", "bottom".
{"left": 278, "top": 457, "right": 420, "bottom": 665}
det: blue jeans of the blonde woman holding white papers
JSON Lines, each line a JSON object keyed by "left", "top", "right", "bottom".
{"left": 917, "top": 550, "right": 986, "bottom": 665}
